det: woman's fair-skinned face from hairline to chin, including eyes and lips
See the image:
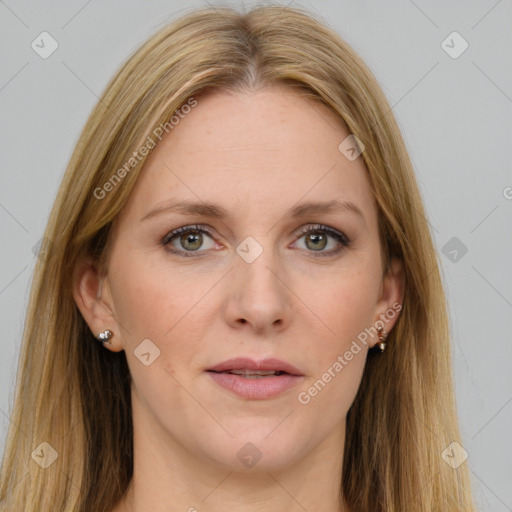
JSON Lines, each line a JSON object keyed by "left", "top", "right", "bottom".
{"left": 78, "top": 88, "right": 402, "bottom": 469}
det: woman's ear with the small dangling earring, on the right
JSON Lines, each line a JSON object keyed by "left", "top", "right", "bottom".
{"left": 371, "top": 258, "right": 405, "bottom": 347}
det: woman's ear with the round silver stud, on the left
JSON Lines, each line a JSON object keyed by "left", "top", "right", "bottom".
{"left": 73, "top": 258, "right": 123, "bottom": 352}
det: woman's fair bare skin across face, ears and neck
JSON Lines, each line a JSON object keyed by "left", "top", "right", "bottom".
{"left": 74, "top": 87, "right": 404, "bottom": 512}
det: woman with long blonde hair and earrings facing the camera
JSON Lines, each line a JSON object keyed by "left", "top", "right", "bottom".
{"left": 0, "top": 6, "right": 473, "bottom": 512}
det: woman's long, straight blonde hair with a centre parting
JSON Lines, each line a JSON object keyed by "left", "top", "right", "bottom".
{"left": 0, "top": 6, "right": 473, "bottom": 512}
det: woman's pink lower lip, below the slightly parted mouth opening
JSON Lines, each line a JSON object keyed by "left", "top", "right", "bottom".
{"left": 207, "top": 372, "right": 304, "bottom": 400}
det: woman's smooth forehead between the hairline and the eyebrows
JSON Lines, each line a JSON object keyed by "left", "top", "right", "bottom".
{"left": 119, "top": 87, "right": 375, "bottom": 224}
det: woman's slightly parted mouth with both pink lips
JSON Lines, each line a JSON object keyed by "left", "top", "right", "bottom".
{"left": 206, "top": 358, "right": 304, "bottom": 400}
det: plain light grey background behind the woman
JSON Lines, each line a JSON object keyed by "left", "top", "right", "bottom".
{"left": 0, "top": 0, "right": 512, "bottom": 512}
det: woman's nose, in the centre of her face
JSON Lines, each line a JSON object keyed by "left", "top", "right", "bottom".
{"left": 224, "top": 249, "right": 293, "bottom": 335}
